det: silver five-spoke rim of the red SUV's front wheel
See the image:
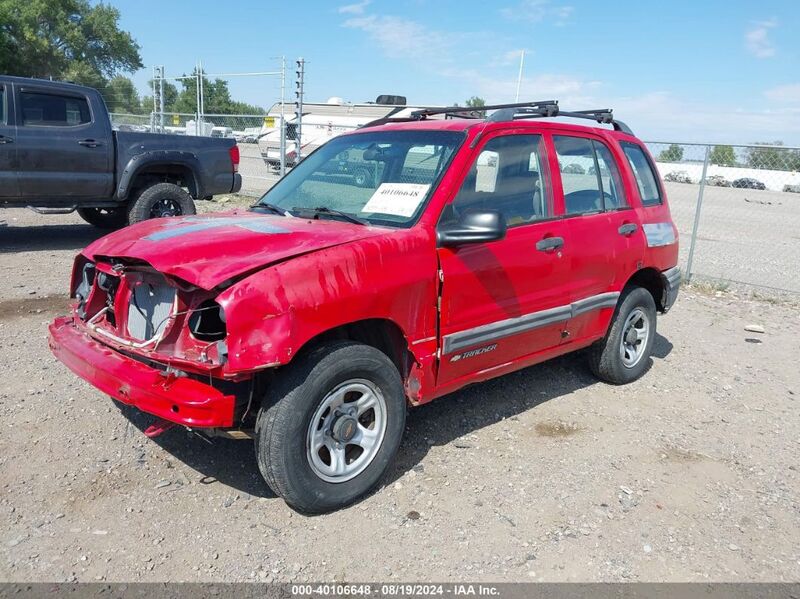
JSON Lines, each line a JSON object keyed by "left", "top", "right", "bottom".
{"left": 306, "top": 379, "right": 387, "bottom": 483}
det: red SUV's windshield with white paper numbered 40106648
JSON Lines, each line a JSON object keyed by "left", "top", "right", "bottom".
{"left": 256, "top": 131, "right": 464, "bottom": 226}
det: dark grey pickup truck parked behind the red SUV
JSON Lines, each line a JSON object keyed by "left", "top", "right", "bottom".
{"left": 0, "top": 75, "right": 242, "bottom": 228}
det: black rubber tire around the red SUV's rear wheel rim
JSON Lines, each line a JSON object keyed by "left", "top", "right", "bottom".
{"left": 589, "top": 287, "right": 656, "bottom": 385}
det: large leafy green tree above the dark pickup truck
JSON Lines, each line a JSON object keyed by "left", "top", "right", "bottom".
{"left": 0, "top": 0, "right": 142, "bottom": 88}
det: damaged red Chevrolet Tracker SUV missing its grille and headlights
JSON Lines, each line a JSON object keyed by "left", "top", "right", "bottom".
{"left": 50, "top": 102, "right": 680, "bottom": 513}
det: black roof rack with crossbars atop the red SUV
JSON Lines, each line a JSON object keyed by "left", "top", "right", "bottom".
{"left": 364, "top": 100, "right": 633, "bottom": 135}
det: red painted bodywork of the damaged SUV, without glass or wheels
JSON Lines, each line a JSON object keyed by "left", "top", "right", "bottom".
{"left": 50, "top": 119, "right": 678, "bottom": 427}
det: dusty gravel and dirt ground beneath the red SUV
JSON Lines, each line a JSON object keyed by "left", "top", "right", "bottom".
{"left": 0, "top": 207, "right": 800, "bottom": 581}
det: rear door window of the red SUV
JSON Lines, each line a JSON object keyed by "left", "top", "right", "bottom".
{"left": 553, "top": 135, "right": 626, "bottom": 214}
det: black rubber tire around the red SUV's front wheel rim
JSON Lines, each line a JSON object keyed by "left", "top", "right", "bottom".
{"left": 255, "top": 342, "right": 406, "bottom": 514}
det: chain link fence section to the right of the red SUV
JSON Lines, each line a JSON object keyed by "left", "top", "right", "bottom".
{"left": 647, "top": 142, "right": 800, "bottom": 294}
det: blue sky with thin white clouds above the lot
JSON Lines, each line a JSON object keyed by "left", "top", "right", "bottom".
{"left": 110, "top": 0, "right": 800, "bottom": 146}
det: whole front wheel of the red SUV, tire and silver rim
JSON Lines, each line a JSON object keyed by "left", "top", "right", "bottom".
{"left": 256, "top": 342, "right": 406, "bottom": 513}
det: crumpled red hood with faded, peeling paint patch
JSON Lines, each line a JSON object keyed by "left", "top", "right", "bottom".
{"left": 83, "top": 211, "right": 386, "bottom": 289}
